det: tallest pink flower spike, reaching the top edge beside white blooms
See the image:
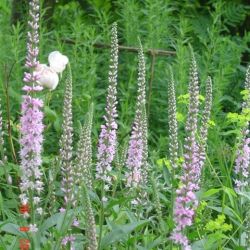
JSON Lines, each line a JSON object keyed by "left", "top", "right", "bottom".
{"left": 20, "top": 0, "right": 44, "bottom": 227}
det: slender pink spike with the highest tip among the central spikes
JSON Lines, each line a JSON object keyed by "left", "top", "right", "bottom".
{"left": 96, "top": 23, "right": 118, "bottom": 200}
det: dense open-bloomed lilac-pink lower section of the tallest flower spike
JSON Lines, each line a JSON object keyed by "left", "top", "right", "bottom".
{"left": 20, "top": 95, "right": 44, "bottom": 207}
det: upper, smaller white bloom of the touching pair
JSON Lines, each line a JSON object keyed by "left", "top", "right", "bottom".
{"left": 48, "top": 51, "right": 69, "bottom": 73}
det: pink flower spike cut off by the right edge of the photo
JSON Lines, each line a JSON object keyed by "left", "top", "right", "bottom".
{"left": 234, "top": 66, "right": 250, "bottom": 191}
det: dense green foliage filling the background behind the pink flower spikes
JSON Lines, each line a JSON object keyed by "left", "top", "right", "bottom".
{"left": 0, "top": 0, "right": 250, "bottom": 250}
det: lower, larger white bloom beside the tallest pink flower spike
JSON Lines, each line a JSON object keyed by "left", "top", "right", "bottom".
{"left": 35, "top": 64, "right": 59, "bottom": 90}
